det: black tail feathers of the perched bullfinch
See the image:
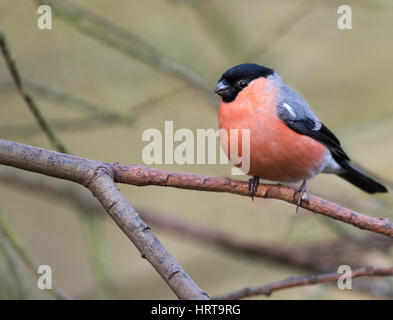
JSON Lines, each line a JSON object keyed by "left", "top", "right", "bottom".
{"left": 338, "top": 162, "right": 388, "bottom": 193}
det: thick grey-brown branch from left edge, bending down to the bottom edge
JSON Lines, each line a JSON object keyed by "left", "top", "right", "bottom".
{"left": 0, "top": 140, "right": 208, "bottom": 299}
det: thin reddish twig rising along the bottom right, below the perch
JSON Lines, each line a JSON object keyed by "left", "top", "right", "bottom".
{"left": 213, "top": 267, "right": 393, "bottom": 300}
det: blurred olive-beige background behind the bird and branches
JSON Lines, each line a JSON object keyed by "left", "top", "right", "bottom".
{"left": 0, "top": 0, "right": 393, "bottom": 299}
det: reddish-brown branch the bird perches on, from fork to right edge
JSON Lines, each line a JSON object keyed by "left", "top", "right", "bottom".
{"left": 114, "top": 164, "right": 393, "bottom": 238}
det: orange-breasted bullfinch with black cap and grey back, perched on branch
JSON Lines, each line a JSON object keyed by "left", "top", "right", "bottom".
{"left": 215, "top": 63, "right": 387, "bottom": 206}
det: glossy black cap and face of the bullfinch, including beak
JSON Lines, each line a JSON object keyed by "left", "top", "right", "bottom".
{"left": 215, "top": 63, "right": 274, "bottom": 102}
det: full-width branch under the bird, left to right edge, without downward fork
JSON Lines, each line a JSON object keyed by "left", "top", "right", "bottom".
{"left": 0, "top": 140, "right": 393, "bottom": 238}
